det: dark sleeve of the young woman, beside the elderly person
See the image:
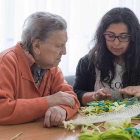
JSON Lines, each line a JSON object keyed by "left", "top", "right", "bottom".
{"left": 74, "top": 55, "right": 95, "bottom": 105}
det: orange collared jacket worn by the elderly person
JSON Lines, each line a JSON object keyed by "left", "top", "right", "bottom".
{"left": 0, "top": 43, "right": 80, "bottom": 124}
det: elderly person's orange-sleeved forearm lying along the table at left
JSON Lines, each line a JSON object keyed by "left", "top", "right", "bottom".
{"left": 0, "top": 97, "right": 48, "bottom": 124}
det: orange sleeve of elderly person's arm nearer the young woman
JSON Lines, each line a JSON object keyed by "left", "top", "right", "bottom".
{"left": 51, "top": 67, "right": 80, "bottom": 120}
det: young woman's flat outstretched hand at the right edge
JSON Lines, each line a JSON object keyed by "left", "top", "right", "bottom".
{"left": 119, "top": 86, "right": 140, "bottom": 97}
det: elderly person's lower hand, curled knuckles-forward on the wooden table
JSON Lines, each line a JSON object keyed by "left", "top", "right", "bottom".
{"left": 44, "top": 106, "right": 66, "bottom": 127}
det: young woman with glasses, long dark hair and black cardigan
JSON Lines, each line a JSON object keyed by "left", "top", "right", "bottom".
{"left": 74, "top": 8, "right": 140, "bottom": 105}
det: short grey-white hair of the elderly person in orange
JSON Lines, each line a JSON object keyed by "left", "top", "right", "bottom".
{"left": 21, "top": 12, "right": 67, "bottom": 50}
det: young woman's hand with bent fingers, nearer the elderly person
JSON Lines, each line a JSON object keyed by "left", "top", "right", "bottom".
{"left": 93, "top": 88, "right": 111, "bottom": 101}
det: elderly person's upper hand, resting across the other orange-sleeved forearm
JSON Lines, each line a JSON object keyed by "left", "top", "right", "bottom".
{"left": 46, "top": 91, "right": 75, "bottom": 108}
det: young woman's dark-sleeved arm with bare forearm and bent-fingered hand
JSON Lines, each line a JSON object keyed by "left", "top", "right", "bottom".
{"left": 74, "top": 55, "right": 111, "bottom": 106}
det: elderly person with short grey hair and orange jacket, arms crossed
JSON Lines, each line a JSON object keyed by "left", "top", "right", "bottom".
{"left": 0, "top": 12, "right": 79, "bottom": 127}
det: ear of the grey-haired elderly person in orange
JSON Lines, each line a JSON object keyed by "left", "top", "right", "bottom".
{"left": 32, "top": 39, "right": 41, "bottom": 54}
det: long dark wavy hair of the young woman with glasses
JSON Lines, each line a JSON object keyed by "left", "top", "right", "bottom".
{"left": 88, "top": 7, "right": 140, "bottom": 87}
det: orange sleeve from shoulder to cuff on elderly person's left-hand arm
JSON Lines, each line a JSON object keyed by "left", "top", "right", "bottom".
{"left": 0, "top": 61, "right": 48, "bottom": 124}
